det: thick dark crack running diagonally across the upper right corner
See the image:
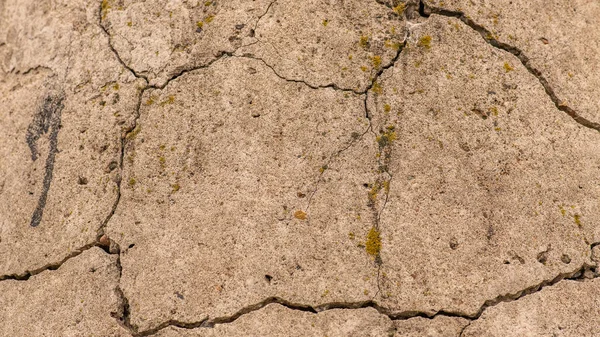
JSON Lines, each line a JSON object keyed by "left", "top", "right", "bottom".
{"left": 419, "top": 0, "right": 600, "bottom": 131}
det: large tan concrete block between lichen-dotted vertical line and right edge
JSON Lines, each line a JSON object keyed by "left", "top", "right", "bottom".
{"left": 369, "top": 15, "right": 600, "bottom": 316}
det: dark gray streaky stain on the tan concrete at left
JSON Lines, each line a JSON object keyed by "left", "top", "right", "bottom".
{"left": 26, "top": 94, "right": 64, "bottom": 227}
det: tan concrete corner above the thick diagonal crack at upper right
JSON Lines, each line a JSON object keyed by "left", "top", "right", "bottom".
{"left": 425, "top": 0, "right": 600, "bottom": 123}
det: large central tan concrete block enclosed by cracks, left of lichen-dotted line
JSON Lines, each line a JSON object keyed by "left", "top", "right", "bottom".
{"left": 108, "top": 57, "right": 377, "bottom": 330}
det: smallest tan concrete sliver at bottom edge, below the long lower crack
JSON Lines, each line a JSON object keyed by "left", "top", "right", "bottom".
{"left": 394, "top": 316, "right": 469, "bottom": 337}
